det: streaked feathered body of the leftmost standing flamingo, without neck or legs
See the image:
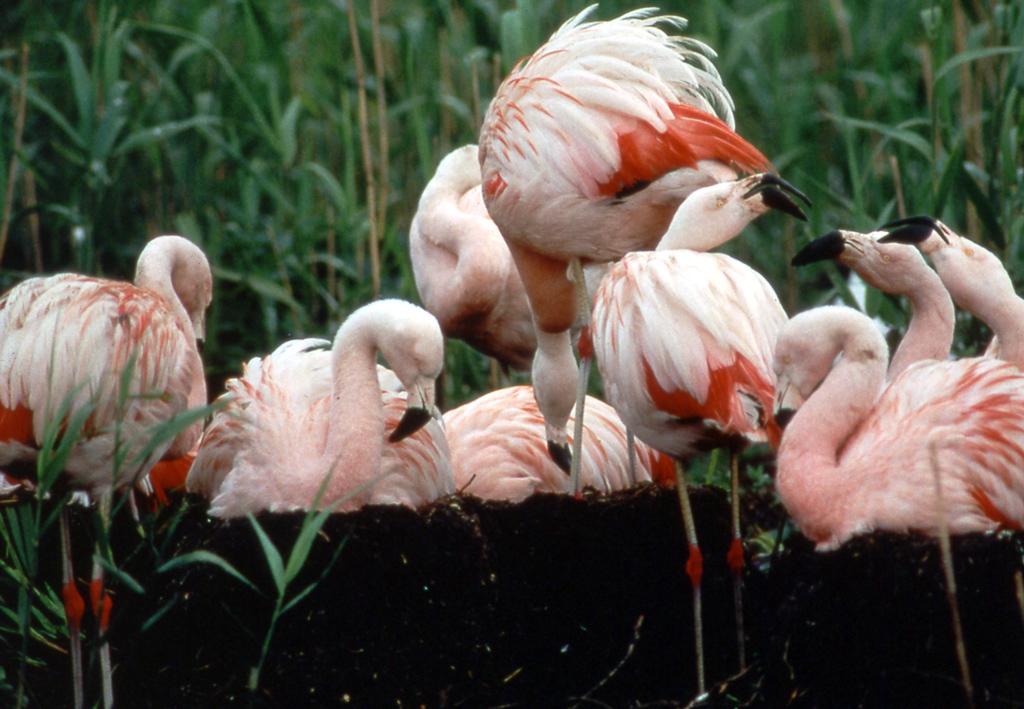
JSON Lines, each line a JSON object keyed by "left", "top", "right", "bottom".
{"left": 0, "top": 275, "right": 195, "bottom": 488}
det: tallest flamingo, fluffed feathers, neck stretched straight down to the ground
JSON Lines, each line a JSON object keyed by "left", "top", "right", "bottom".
{"left": 479, "top": 7, "right": 770, "bottom": 477}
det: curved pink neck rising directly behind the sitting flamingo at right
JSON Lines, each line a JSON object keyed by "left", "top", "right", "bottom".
{"left": 887, "top": 269, "right": 956, "bottom": 381}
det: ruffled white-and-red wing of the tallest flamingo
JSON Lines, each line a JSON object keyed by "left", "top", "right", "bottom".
{"left": 480, "top": 12, "right": 769, "bottom": 200}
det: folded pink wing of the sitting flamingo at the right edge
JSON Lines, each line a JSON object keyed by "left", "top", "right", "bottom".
{"left": 840, "top": 358, "right": 1024, "bottom": 533}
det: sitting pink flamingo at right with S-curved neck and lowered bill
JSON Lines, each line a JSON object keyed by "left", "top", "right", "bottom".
{"left": 775, "top": 306, "right": 1024, "bottom": 550}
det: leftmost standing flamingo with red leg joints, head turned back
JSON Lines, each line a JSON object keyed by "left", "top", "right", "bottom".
{"left": 0, "top": 236, "right": 213, "bottom": 707}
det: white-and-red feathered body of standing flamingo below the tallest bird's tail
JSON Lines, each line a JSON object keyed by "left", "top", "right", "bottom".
{"left": 593, "top": 250, "right": 786, "bottom": 458}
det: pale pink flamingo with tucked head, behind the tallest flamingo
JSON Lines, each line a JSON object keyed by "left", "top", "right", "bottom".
{"left": 409, "top": 145, "right": 537, "bottom": 370}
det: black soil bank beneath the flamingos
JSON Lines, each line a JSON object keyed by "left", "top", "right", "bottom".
{"left": 8, "top": 486, "right": 1024, "bottom": 709}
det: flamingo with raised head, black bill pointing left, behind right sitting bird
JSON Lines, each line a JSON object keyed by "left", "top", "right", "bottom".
{"left": 793, "top": 230, "right": 956, "bottom": 381}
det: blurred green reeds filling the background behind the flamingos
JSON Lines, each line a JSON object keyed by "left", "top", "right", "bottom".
{"left": 0, "top": 0, "right": 1024, "bottom": 405}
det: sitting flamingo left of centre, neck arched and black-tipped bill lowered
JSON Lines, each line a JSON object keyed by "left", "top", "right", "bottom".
{"left": 187, "top": 299, "right": 454, "bottom": 518}
